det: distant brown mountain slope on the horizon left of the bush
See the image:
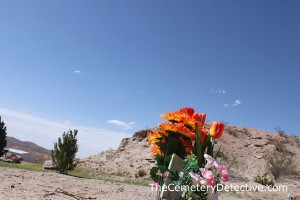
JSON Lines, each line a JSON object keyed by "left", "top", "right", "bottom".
{"left": 6, "top": 136, "right": 51, "bottom": 163}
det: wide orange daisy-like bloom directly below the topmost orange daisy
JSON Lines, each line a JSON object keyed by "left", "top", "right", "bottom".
{"left": 160, "top": 122, "right": 196, "bottom": 140}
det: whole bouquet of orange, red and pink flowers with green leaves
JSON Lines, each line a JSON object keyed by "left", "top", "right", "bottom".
{"left": 148, "top": 108, "right": 229, "bottom": 200}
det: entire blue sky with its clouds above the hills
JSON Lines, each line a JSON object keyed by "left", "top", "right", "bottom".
{"left": 0, "top": 0, "right": 300, "bottom": 157}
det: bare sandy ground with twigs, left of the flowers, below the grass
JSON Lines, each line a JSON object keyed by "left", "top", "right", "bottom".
{"left": 0, "top": 168, "right": 156, "bottom": 200}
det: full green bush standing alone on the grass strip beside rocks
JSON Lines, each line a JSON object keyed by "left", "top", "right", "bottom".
{"left": 51, "top": 130, "right": 78, "bottom": 173}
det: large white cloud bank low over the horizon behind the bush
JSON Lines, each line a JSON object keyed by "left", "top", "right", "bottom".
{"left": 0, "top": 108, "right": 130, "bottom": 158}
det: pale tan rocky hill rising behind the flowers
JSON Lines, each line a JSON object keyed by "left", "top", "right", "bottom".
{"left": 78, "top": 126, "right": 300, "bottom": 199}
